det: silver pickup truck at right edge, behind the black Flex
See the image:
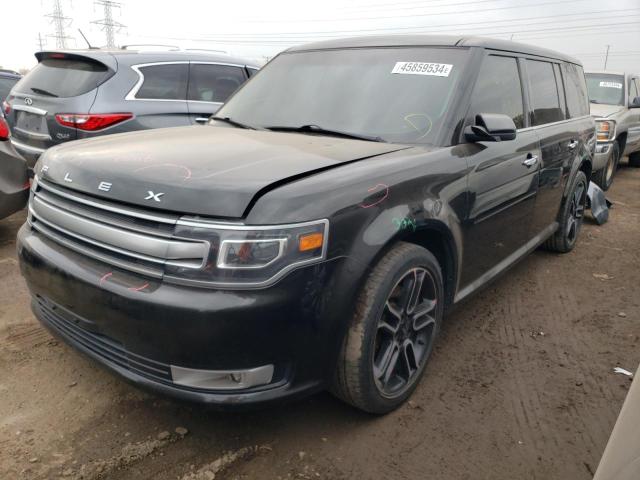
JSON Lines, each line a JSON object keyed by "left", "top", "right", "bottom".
{"left": 585, "top": 72, "right": 640, "bottom": 190}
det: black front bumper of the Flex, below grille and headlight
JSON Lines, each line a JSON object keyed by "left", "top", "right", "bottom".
{"left": 18, "top": 224, "right": 351, "bottom": 406}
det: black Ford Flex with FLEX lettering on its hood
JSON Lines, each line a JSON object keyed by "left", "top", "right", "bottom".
{"left": 18, "top": 36, "right": 595, "bottom": 413}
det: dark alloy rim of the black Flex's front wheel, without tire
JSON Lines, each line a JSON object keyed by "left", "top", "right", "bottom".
{"left": 373, "top": 267, "right": 437, "bottom": 398}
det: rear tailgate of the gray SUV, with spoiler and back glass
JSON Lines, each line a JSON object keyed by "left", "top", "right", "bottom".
{"left": 7, "top": 53, "right": 115, "bottom": 159}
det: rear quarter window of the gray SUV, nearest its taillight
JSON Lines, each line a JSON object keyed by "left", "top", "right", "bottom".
{"left": 136, "top": 63, "right": 189, "bottom": 100}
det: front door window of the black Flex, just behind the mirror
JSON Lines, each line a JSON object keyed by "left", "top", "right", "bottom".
{"left": 469, "top": 55, "right": 524, "bottom": 128}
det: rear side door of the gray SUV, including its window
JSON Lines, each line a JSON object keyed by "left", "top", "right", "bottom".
{"left": 187, "top": 62, "right": 247, "bottom": 123}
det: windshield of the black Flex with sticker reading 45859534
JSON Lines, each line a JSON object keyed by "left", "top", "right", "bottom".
{"left": 216, "top": 47, "right": 469, "bottom": 143}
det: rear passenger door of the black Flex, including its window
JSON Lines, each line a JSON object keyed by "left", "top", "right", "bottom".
{"left": 525, "top": 58, "right": 591, "bottom": 235}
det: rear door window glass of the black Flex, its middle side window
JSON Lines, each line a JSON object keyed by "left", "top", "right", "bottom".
{"left": 527, "top": 60, "right": 564, "bottom": 126}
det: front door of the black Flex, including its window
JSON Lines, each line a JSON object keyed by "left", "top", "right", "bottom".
{"left": 462, "top": 54, "right": 540, "bottom": 290}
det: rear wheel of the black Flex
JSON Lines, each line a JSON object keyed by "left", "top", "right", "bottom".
{"left": 545, "top": 171, "right": 587, "bottom": 253}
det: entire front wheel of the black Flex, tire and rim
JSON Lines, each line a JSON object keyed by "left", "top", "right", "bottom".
{"left": 332, "top": 243, "right": 444, "bottom": 413}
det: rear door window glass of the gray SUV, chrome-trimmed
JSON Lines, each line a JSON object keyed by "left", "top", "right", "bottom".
{"left": 187, "top": 63, "right": 246, "bottom": 103}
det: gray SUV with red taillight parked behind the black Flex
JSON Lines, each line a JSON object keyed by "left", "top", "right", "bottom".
{"left": 3, "top": 49, "right": 257, "bottom": 166}
